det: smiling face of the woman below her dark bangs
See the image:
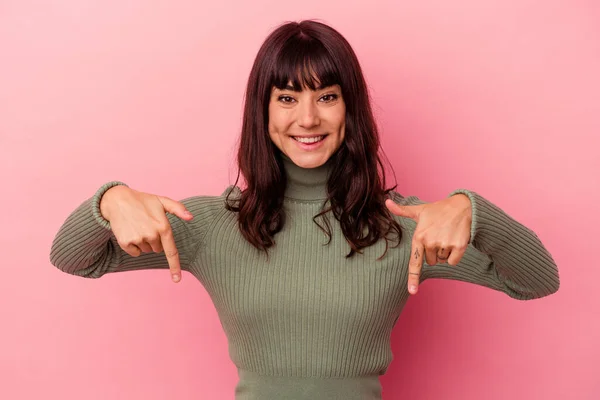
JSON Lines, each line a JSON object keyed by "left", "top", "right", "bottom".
{"left": 269, "top": 82, "right": 346, "bottom": 168}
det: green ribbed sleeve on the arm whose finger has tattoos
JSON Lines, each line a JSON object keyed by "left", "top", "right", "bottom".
{"left": 395, "top": 189, "right": 560, "bottom": 300}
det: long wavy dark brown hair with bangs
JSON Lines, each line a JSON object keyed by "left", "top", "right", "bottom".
{"left": 226, "top": 20, "right": 402, "bottom": 259}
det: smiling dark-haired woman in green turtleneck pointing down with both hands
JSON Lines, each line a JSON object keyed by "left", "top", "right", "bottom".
{"left": 50, "top": 21, "right": 559, "bottom": 400}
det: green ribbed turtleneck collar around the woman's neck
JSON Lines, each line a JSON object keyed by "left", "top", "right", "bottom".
{"left": 281, "top": 152, "right": 332, "bottom": 201}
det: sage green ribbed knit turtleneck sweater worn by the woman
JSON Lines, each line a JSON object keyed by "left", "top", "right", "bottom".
{"left": 50, "top": 157, "right": 559, "bottom": 400}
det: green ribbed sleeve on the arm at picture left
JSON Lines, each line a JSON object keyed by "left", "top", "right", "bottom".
{"left": 50, "top": 181, "right": 220, "bottom": 278}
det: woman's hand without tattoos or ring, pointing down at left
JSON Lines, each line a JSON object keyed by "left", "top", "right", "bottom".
{"left": 100, "top": 185, "right": 194, "bottom": 282}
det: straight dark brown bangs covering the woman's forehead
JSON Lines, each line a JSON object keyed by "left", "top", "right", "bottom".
{"left": 272, "top": 36, "right": 341, "bottom": 92}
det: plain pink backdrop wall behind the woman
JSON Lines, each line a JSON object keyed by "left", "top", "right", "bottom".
{"left": 0, "top": 0, "right": 600, "bottom": 400}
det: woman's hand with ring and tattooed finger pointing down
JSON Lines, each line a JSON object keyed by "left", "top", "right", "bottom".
{"left": 385, "top": 193, "right": 472, "bottom": 294}
